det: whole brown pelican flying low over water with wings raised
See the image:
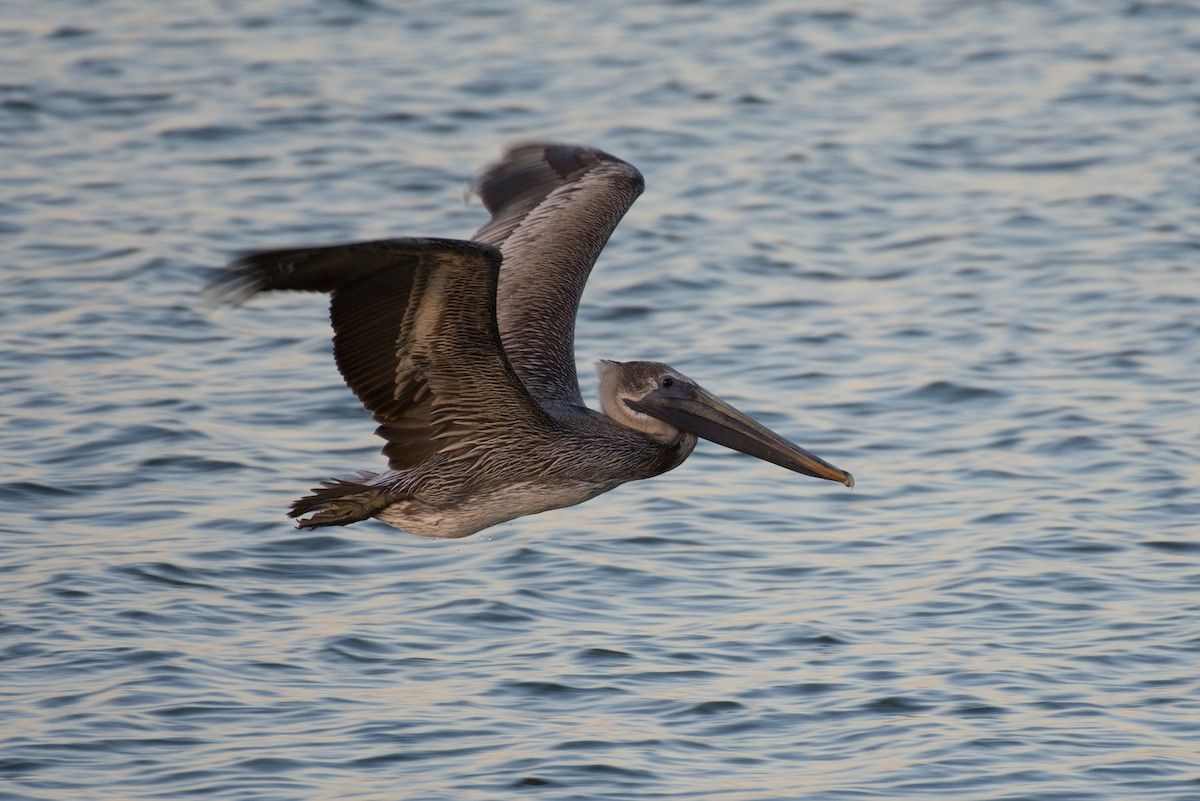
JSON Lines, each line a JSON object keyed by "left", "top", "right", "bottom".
{"left": 211, "top": 144, "right": 854, "bottom": 537}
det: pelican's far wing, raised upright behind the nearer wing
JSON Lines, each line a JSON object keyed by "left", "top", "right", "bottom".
{"left": 475, "top": 144, "right": 644, "bottom": 404}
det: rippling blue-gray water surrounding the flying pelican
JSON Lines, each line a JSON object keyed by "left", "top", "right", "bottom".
{"left": 0, "top": 0, "right": 1200, "bottom": 801}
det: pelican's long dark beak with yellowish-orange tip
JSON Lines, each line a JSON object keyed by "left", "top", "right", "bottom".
{"left": 625, "top": 385, "right": 854, "bottom": 487}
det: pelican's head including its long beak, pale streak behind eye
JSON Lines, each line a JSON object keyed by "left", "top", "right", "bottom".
{"left": 596, "top": 361, "right": 854, "bottom": 487}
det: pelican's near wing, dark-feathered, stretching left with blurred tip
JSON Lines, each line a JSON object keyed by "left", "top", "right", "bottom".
{"left": 215, "top": 239, "right": 544, "bottom": 470}
